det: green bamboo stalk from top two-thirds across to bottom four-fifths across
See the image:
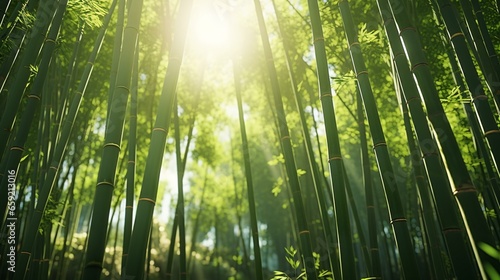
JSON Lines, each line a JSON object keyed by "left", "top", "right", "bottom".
{"left": 339, "top": 0, "right": 420, "bottom": 279}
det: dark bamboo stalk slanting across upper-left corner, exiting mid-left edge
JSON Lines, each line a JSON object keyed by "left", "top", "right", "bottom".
{"left": 0, "top": 0, "right": 60, "bottom": 159}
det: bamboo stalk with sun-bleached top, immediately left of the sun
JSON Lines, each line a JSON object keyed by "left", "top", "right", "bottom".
{"left": 123, "top": 0, "right": 193, "bottom": 279}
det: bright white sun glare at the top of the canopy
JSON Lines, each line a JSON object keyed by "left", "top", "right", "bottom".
{"left": 190, "top": 1, "right": 231, "bottom": 52}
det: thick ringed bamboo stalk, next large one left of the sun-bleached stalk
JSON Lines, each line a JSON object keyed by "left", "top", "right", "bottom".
{"left": 83, "top": 0, "right": 142, "bottom": 280}
